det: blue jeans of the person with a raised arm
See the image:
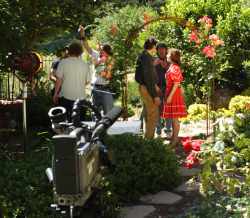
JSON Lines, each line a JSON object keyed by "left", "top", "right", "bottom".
{"left": 92, "top": 87, "right": 114, "bottom": 114}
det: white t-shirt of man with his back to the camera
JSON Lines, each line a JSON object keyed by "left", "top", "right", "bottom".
{"left": 56, "top": 57, "right": 91, "bottom": 100}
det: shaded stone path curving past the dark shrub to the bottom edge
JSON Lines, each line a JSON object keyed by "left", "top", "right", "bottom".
{"left": 121, "top": 168, "right": 200, "bottom": 218}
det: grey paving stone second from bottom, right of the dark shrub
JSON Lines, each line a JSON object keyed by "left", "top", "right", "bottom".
{"left": 140, "top": 191, "right": 182, "bottom": 205}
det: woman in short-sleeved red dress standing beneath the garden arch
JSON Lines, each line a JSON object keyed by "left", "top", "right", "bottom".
{"left": 161, "top": 49, "right": 187, "bottom": 146}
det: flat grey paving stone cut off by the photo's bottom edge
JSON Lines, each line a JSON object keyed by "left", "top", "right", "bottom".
{"left": 121, "top": 205, "right": 155, "bottom": 218}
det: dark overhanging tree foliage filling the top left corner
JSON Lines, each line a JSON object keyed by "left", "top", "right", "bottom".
{"left": 0, "top": 0, "right": 131, "bottom": 54}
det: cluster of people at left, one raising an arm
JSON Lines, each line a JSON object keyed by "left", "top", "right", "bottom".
{"left": 50, "top": 26, "right": 114, "bottom": 120}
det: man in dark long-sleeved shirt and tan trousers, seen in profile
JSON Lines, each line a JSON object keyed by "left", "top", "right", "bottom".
{"left": 135, "top": 38, "right": 161, "bottom": 139}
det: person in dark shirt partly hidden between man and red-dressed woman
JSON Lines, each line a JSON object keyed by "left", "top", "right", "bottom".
{"left": 154, "top": 43, "right": 171, "bottom": 136}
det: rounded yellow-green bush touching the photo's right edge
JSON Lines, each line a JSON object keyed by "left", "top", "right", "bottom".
{"left": 229, "top": 95, "right": 250, "bottom": 113}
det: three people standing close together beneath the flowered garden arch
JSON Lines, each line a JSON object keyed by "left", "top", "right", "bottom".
{"left": 135, "top": 38, "right": 187, "bottom": 146}
